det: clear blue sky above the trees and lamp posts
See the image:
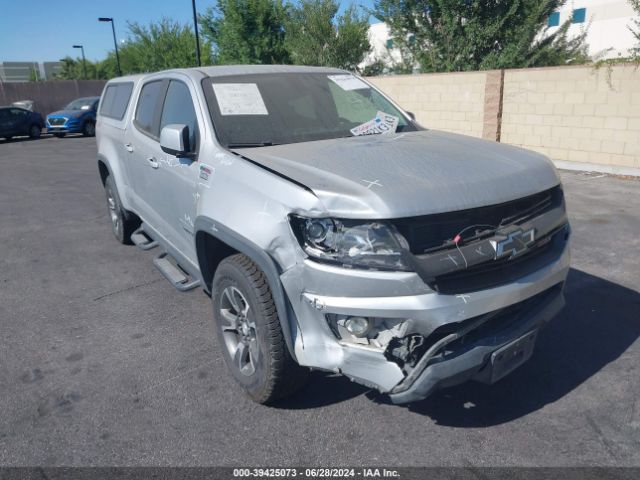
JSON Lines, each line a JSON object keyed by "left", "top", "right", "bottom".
{"left": 0, "top": 0, "right": 373, "bottom": 62}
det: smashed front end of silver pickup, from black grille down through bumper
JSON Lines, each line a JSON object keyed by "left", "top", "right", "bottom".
{"left": 281, "top": 186, "right": 570, "bottom": 403}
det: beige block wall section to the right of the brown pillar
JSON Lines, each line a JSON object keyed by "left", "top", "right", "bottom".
{"left": 501, "top": 65, "right": 640, "bottom": 168}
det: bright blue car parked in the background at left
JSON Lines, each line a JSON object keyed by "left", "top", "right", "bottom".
{"left": 47, "top": 97, "right": 100, "bottom": 137}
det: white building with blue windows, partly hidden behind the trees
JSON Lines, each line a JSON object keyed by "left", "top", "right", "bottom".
{"left": 360, "top": 0, "right": 635, "bottom": 68}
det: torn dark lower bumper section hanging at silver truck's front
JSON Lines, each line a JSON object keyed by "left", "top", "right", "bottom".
{"left": 385, "top": 284, "right": 564, "bottom": 403}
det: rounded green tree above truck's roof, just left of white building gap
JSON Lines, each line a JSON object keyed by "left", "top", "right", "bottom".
{"left": 285, "top": 0, "right": 371, "bottom": 70}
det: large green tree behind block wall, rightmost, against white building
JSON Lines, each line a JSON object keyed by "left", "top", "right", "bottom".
{"left": 374, "top": 0, "right": 588, "bottom": 72}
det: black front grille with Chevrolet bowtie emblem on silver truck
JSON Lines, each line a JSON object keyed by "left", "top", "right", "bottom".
{"left": 394, "top": 186, "right": 570, "bottom": 294}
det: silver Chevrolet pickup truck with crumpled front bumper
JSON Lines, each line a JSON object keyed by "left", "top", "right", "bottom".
{"left": 97, "top": 66, "right": 570, "bottom": 403}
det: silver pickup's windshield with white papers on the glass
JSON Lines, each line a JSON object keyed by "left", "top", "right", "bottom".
{"left": 202, "top": 72, "right": 417, "bottom": 148}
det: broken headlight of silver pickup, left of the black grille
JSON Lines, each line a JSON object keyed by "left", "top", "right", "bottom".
{"left": 291, "top": 216, "right": 413, "bottom": 271}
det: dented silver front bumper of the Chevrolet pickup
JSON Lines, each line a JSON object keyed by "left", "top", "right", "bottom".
{"left": 281, "top": 239, "right": 570, "bottom": 403}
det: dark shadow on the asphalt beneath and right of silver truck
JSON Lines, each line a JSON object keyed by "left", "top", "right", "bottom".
{"left": 278, "top": 269, "right": 640, "bottom": 420}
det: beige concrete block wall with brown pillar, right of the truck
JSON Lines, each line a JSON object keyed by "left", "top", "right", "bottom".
{"left": 368, "top": 64, "right": 640, "bottom": 174}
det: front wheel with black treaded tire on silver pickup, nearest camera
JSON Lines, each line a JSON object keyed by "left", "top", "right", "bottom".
{"left": 211, "top": 254, "right": 309, "bottom": 404}
